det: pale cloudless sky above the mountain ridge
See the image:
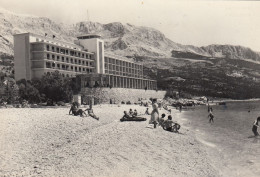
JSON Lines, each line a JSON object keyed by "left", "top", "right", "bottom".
{"left": 0, "top": 0, "right": 260, "bottom": 52}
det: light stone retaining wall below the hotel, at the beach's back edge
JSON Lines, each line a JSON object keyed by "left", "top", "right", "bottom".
{"left": 81, "top": 88, "right": 166, "bottom": 103}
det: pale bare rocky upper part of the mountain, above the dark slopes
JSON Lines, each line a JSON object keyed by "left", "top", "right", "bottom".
{"left": 0, "top": 8, "right": 260, "bottom": 61}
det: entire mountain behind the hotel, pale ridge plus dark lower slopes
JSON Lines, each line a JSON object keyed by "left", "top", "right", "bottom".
{"left": 0, "top": 8, "right": 260, "bottom": 99}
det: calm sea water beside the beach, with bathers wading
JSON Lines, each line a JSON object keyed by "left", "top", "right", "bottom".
{"left": 181, "top": 101, "right": 260, "bottom": 177}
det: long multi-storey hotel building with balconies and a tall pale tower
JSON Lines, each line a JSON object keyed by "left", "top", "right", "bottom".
{"left": 14, "top": 33, "right": 157, "bottom": 90}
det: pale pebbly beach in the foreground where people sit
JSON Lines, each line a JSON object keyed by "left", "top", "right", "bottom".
{"left": 0, "top": 105, "right": 219, "bottom": 177}
